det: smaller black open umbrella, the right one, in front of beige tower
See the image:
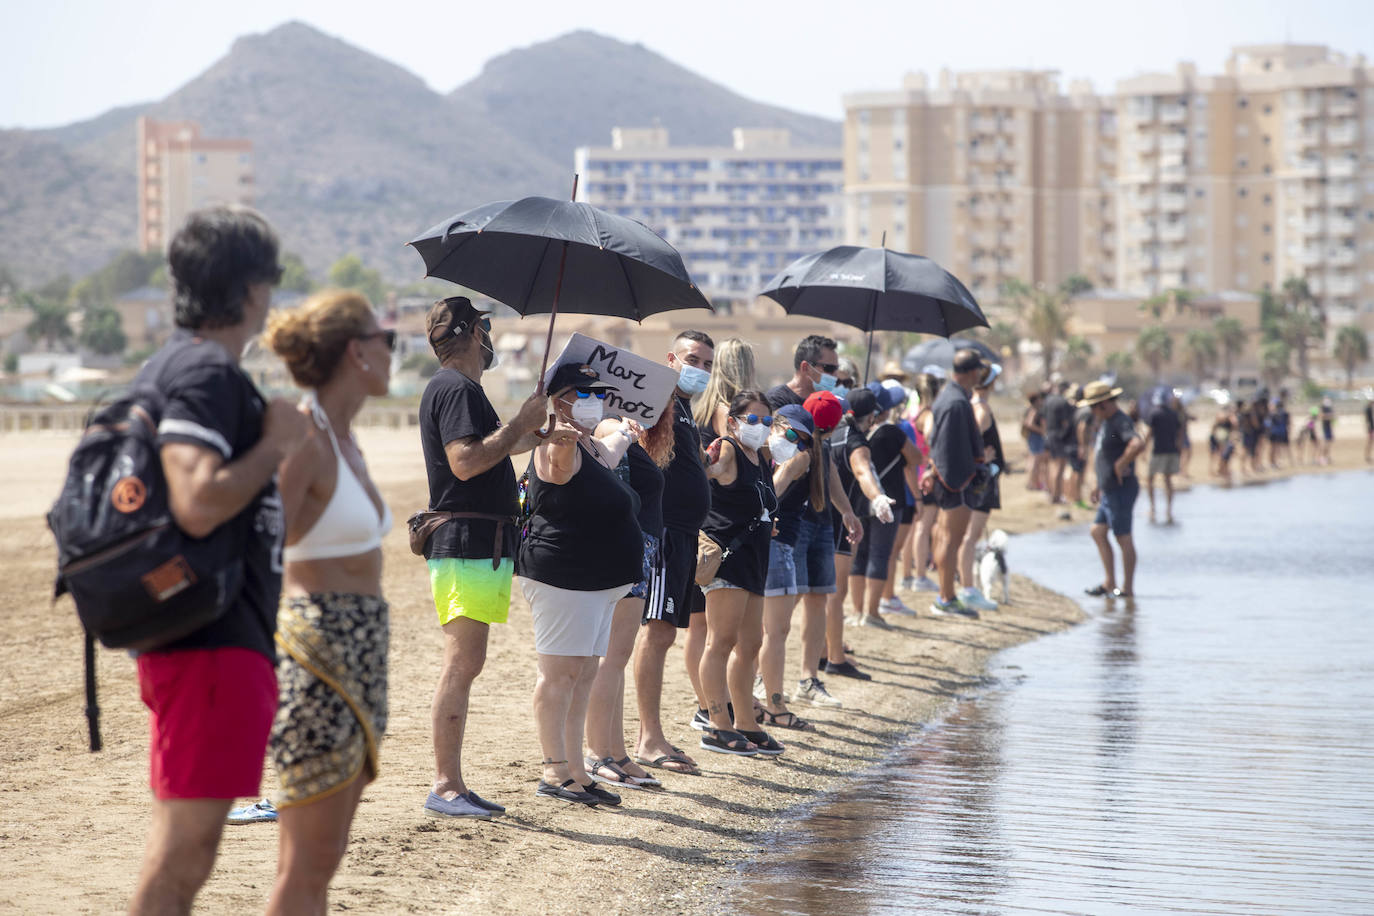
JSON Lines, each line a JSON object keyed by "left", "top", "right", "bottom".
{"left": 763, "top": 244, "right": 988, "bottom": 380}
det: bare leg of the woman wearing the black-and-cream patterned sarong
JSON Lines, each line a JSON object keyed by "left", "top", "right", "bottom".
{"left": 267, "top": 773, "right": 368, "bottom": 916}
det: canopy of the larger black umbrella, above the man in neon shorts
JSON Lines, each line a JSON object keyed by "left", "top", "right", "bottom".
{"left": 408, "top": 198, "right": 712, "bottom": 321}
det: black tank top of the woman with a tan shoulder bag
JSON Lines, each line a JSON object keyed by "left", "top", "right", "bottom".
{"left": 701, "top": 438, "right": 778, "bottom": 595}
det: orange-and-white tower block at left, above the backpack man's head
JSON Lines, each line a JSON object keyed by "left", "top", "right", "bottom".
{"left": 137, "top": 117, "right": 253, "bottom": 253}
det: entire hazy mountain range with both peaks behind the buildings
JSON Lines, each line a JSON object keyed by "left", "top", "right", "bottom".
{"left": 0, "top": 22, "right": 840, "bottom": 283}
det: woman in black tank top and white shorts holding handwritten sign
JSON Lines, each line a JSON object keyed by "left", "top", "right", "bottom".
{"left": 517, "top": 363, "right": 644, "bottom": 805}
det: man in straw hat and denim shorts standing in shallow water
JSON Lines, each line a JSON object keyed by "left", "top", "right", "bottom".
{"left": 1079, "top": 382, "right": 1145, "bottom": 597}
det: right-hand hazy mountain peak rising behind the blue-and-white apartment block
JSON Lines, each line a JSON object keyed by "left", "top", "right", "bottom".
{"left": 449, "top": 30, "right": 841, "bottom": 162}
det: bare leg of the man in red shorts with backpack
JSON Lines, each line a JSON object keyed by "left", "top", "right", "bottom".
{"left": 129, "top": 798, "right": 234, "bottom": 916}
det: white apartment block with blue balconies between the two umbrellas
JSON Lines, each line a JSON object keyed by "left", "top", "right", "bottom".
{"left": 574, "top": 128, "right": 844, "bottom": 304}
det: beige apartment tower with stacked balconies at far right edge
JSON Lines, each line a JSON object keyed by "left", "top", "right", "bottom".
{"left": 1117, "top": 44, "right": 1374, "bottom": 327}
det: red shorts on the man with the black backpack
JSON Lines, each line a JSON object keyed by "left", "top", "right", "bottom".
{"left": 139, "top": 648, "right": 276, "bottom": 799}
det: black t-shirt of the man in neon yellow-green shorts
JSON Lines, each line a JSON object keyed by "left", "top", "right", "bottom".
{"left": 420, "top": 369, "right": 519, "bottom": 559}
